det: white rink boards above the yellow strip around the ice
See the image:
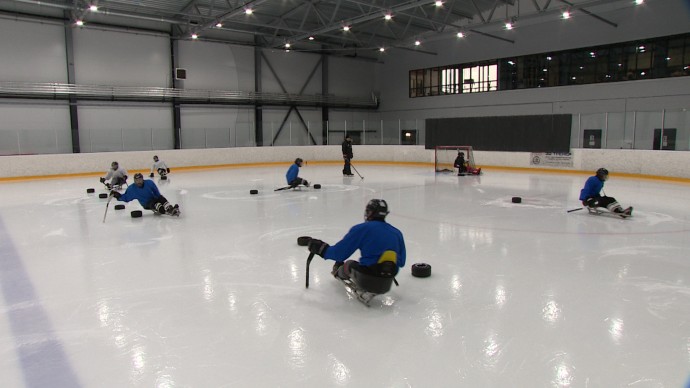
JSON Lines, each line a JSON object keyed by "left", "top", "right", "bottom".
{"left": 5, "top": 145, "right": 690, "bottom": 179}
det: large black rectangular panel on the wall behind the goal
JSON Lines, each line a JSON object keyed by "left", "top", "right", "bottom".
{"left": 425, "top": 115, "right": 572, "bottom": 152}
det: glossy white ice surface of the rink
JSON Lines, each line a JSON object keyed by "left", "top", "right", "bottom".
{"left": 0, "top": 163, "right": 690, "bottom": 388}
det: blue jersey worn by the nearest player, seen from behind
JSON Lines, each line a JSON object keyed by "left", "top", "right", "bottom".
{"left": 324, "top": 220, "right": 406, "bottom": 268}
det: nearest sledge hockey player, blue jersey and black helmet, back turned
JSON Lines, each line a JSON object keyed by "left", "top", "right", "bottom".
{"left": 309, "top": 199, "right": 406, "bottom": 280}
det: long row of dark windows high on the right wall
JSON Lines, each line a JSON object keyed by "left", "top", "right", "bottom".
{"left": 410, "top": 34, "right": 690, "bottom": 97}
